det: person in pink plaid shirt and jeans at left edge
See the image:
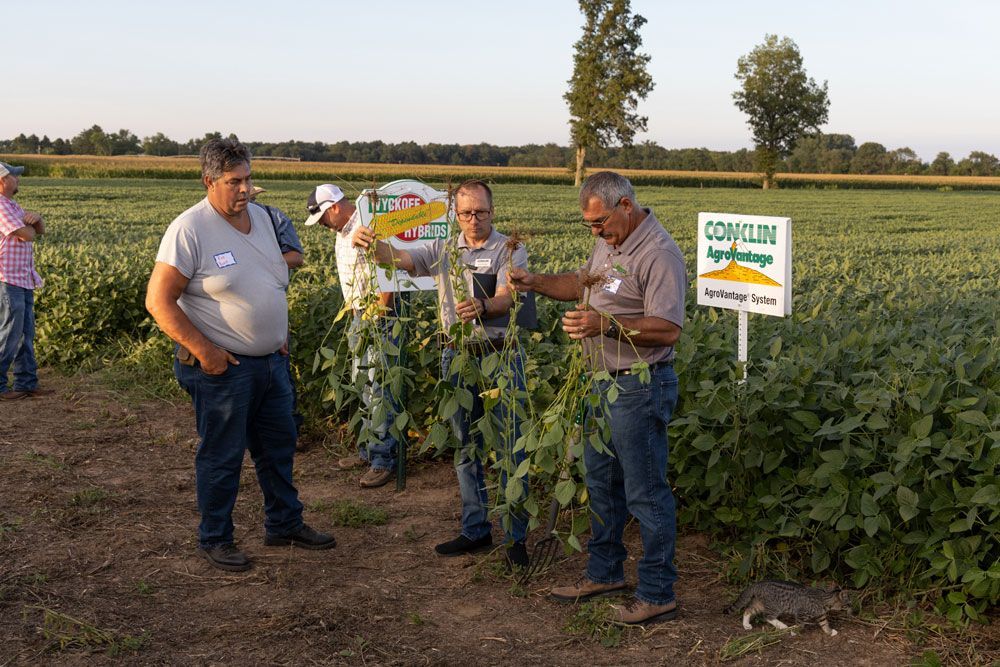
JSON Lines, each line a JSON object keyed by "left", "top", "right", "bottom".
{"left": 0, "top": 162, "right": 52, "bottom": 401}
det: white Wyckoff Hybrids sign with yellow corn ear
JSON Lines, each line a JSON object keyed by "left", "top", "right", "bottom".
{"left": 355, "top": 179, "right": 448, "bottom": 292}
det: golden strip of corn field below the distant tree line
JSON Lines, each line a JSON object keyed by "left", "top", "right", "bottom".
{"left": 0, "top": 155, "right": 1000, "bottom": 191}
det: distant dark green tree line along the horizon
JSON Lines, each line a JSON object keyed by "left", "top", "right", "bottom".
{"left": 0, "top": 125, "right": 1000, "bottom": 176}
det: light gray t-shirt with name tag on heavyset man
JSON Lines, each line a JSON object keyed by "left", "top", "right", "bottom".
{"left": 156, "top": 198, "right": 288, "bottom": 356}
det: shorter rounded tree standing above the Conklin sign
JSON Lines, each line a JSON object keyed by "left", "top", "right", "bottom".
{"left": 733, "top": 35, "right": 830, "bottom": 189}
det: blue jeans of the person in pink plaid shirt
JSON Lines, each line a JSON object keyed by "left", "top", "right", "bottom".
{"left": 0, "top": 282, "right": 38, "bottom": 392}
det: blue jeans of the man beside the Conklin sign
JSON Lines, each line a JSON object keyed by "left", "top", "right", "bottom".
{"left": 584, "top": 366, "right": 677, "bottom": 605}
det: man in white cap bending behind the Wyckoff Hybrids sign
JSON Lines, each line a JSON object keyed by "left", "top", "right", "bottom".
{"left": 305, "top": 184, "right": 401, "bottom": 489}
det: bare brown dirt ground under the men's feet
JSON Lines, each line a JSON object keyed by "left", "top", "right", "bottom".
{"left": 0, "top": 373, "right": 1000, "bottom": 665}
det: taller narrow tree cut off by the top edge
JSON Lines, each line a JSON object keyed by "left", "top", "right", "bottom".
{"left": 563, "top": 0, "right": 653, "bottom": 185}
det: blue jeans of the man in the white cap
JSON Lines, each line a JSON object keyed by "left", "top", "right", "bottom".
{"left": 347, "top": 315, "right": 402, "bottom": 470}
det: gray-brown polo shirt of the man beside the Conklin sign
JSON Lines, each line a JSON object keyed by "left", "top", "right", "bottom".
{"left": 583, "top": 209, "right": 688, "bottom": 371}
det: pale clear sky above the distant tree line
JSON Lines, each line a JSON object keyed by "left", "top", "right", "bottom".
{"left": 7, "top": 0, "right": 1000, "bottom": 160}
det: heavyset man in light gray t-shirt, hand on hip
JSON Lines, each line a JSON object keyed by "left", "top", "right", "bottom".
{"left": 146, "top": 139, "right": 336, "bottom": 572}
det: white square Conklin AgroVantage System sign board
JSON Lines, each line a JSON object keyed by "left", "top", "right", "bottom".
{"left": 697, "top": 213, "right": 792, "bottom": 317}
